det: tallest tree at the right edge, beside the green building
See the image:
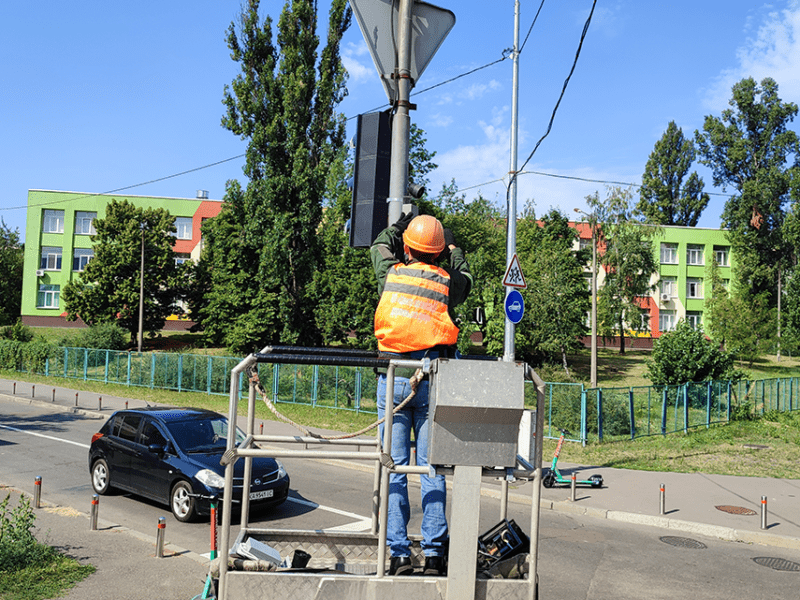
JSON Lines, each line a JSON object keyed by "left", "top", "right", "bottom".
{"left": 695, "top": 78, "right": 800, "bottom": 307}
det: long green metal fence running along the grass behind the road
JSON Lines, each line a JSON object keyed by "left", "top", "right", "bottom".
{"left": 15, "top": 348, "right": 800, "bottom": 443}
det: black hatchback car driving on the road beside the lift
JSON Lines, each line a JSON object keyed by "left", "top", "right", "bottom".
{"left": 89, "top": 407, "right": 289, "bottom": 521}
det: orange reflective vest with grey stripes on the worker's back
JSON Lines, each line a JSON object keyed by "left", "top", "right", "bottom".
{"left": 375, "top": 262, "right": 458, "bottom": 353}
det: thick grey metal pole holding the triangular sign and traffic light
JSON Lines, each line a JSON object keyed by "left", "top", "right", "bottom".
{"left": 386, "top": 0, "right": 414, "bottom": 224}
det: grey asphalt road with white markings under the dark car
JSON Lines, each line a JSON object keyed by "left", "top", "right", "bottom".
{"left": 0, "top": 400, "right": 800, "bottom": 600}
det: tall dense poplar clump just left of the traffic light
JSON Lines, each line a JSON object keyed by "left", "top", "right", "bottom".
{"left": 196, "top": 0, "right": 352, "bottom": 351}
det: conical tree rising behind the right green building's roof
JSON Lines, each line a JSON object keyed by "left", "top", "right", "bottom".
{"left": 636, "top": 121, "right": 709, "bottom": 227}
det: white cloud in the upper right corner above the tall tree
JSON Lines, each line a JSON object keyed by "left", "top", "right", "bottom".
{"left": 704, "top": 0, "right": 800, "bottom": 111}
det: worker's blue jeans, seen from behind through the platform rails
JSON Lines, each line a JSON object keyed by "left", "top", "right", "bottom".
{"left": 378, "top": 375, "right": 447, "bottom": 556}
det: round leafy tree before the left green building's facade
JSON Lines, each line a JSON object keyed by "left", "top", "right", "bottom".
{"left": 61, "top": 200, "right": 180, "bottom": 340}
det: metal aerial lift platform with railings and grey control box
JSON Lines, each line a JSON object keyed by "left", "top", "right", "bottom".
{"left": 212, "top": 346, "right": 544, "bottom": 600}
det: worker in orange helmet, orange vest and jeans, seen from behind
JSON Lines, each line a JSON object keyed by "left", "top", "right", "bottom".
{"left": 370, "top": 213, "right": 472, "bottom": 575}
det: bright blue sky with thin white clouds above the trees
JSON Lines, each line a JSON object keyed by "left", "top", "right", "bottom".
{"left": 0, "top": 0, "right": 800, "bottom": 239}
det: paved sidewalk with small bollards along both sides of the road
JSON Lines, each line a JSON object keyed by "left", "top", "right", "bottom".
{"left": 0, "top": 379, "right": 800, "bottom": 600}
